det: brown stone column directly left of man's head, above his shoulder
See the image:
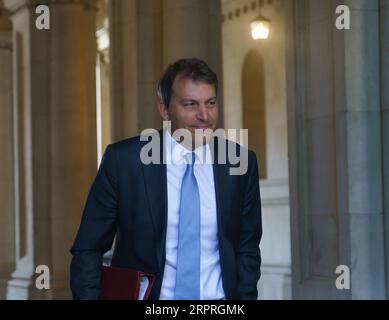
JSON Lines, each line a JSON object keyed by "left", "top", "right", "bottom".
{"left": 109, "top": 0, "right": 162, "bottom": 141}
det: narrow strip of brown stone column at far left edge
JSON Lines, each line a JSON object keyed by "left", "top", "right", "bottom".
{"left": 0, "top": 2, "right": 15, "bottom": 300}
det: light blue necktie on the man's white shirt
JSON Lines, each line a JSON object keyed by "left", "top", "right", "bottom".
{"left": 175, "top": 152, "right": 200, "bottom": 300}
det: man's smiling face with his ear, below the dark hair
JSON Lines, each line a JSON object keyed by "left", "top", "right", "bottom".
{"left": 159, "top": 75, "right": 219, "bottom": 147}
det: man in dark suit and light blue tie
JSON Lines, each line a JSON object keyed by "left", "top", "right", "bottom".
{"left": 71, "top": 59, "right": 262, "bottom": 299}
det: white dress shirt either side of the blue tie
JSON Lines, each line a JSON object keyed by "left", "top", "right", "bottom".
{"left": 160, "top": 130, "right": 225, "bottom": 300}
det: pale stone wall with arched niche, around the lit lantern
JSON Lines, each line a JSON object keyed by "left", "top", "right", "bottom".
{"left": 222, "top": 0, "right": 291, "bottom": 299}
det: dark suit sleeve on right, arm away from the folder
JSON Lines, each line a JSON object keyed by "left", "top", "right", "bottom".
{"left": 237, "top": 151, "right": 262, "bottom": 300}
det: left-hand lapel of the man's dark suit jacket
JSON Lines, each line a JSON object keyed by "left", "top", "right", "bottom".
{"left": 142, "top": 130, "right": 167, "bottom": 271}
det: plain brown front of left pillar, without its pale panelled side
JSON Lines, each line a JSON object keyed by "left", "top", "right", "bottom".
{"left": 48, "top": 1, "right": 97, "bottom": 297}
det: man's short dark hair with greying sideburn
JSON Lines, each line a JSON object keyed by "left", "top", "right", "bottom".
{"left": 158, "top": 58, "right": 218, "bottom": 107}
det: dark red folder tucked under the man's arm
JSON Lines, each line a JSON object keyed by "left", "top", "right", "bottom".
{"left": 100, "top": 266, "right": 155, "bottom": 300}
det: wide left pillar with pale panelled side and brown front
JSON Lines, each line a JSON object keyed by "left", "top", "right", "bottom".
{"left": 5, "top": 0, "right": 97, "bottom": 299}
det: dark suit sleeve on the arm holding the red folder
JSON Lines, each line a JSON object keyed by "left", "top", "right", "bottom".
{"left": 70, "top": 146, "right": 118, "bottom": 300}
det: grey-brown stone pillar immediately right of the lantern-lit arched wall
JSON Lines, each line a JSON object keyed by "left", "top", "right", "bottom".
{"left": 285, "top": 0, "right": 350, "bottom": 299}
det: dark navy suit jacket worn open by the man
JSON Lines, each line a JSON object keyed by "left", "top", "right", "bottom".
{"left": 70, "top": 131, "right": 262, "bottom": 299}
